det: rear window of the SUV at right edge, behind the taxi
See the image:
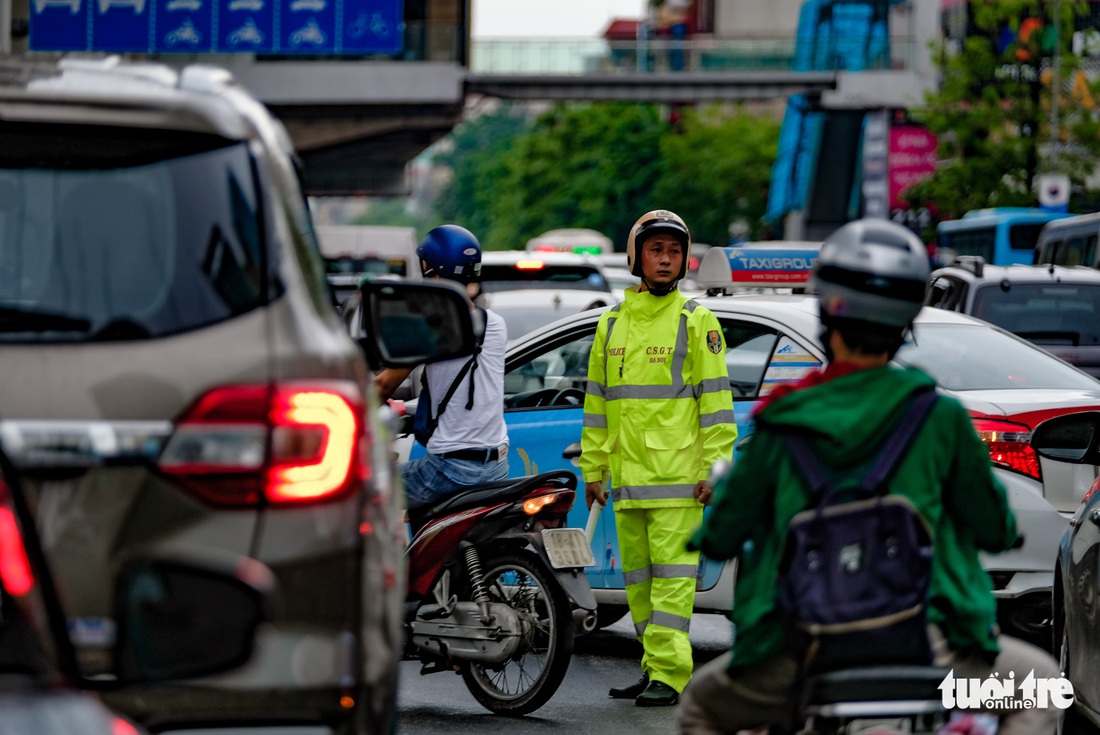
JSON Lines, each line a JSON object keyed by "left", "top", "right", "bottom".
{"left": 974, "top": 282, "right": 1100, "bottom": 345}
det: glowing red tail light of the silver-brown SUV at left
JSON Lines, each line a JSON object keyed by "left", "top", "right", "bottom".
{"left": 157, "top": 382, "right": 370, "bottom": 507}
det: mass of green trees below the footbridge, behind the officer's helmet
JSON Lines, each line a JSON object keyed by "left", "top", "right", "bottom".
{"left": 438, "top": 102, "right": 779, "bottom": 250}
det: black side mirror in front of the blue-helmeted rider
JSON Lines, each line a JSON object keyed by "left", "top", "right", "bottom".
{"left": 354, "top": 281, "right": 485, "bottom": 368}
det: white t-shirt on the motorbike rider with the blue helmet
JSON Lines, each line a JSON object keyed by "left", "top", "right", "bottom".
{"left": 424, "top": 309, "right": 508, "bottom": 454}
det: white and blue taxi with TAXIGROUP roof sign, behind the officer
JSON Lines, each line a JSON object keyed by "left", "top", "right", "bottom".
{"left": 411, "top": 243, "right": 1100, "bottom": 641}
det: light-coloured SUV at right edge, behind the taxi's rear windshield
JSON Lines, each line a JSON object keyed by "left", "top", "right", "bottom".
{"left": 924, "top": 255, "right": 1100, "bottom": 377}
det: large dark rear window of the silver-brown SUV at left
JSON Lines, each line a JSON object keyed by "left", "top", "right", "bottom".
{"left": 0, "top": 122, "right": 278, "bottom": 342}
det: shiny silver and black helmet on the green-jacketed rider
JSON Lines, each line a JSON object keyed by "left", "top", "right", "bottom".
{"left": 811, "top": 219, "right": 930, "bottom": 329}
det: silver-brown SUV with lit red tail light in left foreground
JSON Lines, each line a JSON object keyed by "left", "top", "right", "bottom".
{"left": 0, "top": 58, "right": 405, "bottom": 732}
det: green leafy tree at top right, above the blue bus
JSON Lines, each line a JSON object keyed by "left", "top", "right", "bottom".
{"left": 904, "top": 0, "right": 1100, "bottom": 218}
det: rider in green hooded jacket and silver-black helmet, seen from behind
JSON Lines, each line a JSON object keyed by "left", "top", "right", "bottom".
{"left": 679, "top": 220, "right": 1060, "bottom": 735}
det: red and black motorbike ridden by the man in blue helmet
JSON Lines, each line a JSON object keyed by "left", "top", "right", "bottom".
{"left": 405, "top": 471, "right": 596, "bottom": 715}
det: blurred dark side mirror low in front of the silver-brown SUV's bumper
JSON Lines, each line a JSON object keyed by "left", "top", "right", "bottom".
{"left": 114, "top": 557, "right": 274, "bottom": 684}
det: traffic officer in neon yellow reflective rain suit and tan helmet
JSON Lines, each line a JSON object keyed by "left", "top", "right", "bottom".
{"left": 580, "top": 209, "right": 737, "bottom": 706}
